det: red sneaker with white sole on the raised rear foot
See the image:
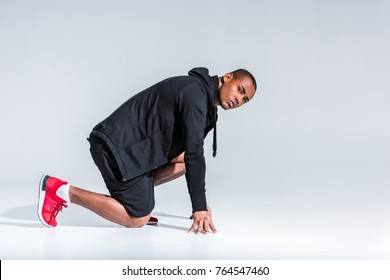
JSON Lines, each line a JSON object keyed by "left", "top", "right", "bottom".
{"left": 38, "top": 175, "right": 68, "bottom": 227}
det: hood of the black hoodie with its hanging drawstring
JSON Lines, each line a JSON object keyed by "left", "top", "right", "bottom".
{"left": 188, "top": 67, "right": 219, "bottom": 157}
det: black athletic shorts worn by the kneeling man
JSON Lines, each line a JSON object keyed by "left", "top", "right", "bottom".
{"left": 88, "top": 137, "right": 155, "bottom": 217}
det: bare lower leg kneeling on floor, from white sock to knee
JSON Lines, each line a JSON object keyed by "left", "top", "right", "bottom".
{"left": 69, "top": 186, "right": 150, "bottom": 227}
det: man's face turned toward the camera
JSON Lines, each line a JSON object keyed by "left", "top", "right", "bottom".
{"left": 217, "top": 73, "right": 255, "bottom": 110}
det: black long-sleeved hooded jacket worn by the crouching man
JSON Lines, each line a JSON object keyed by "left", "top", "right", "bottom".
{"left": 91, "top": 68, "right": 218, "bottom": 211}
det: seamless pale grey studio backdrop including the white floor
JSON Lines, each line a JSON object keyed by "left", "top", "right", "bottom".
{"left": 0, "top": 0, "right": 390, "bottom": 259}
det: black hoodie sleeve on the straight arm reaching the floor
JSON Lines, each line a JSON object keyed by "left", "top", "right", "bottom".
{"left": 178, "top": 84, "right": 207, "bottom": 212}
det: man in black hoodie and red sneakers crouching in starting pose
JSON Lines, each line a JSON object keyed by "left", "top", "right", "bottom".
{"left": 38, "top": 68, "right": 257, "bottom": 233}
